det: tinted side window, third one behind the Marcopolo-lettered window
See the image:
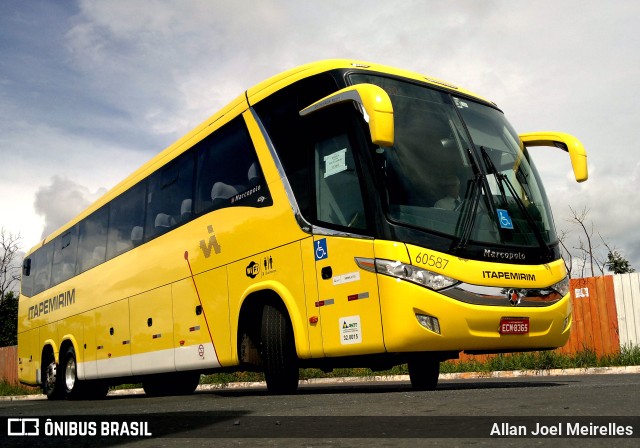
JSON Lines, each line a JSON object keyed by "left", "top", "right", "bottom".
{"left": 76, "top": 206, "right": 109, "bottom": 274}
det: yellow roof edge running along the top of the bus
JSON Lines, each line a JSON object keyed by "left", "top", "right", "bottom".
{"left": 26, "top": 59, "right": 493, "bottom": 256}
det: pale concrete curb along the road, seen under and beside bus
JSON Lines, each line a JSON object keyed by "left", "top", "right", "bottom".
{"left": 0, "top": 366, "right": 640, "bottom": 401}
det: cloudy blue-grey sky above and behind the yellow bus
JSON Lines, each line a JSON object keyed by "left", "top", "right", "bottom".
{"left": 0, "top": 0, "right": 640, "bottom": 270}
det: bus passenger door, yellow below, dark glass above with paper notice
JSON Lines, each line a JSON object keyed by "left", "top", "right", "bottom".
{"left": 311, "top": 116, "right": 385, "bottom": 356}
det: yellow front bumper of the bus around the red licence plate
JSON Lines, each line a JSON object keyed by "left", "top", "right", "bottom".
{"left": 378, "top": 275, "right": 572, "bottom": 353}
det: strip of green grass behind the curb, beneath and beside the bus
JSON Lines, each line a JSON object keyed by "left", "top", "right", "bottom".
{"left": 0, "top": 345, "right": 640, "bottom": 396}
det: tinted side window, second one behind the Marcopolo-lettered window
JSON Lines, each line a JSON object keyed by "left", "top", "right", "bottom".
{"left": 107, "top": 182, "right": 146, "bottom": 259}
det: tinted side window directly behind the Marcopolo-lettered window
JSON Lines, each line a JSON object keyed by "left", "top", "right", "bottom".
{"left": 146, "top": 152, "right": 193, "bottom": 240}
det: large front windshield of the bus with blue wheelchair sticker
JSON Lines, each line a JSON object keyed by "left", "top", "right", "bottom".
{"left": 350, "top": 74, "right": 556, "bottom": 247}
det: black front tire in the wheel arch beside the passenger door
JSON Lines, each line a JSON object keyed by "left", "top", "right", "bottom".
{"left": 261, "top": 305, "right": 300, "bottom": 394}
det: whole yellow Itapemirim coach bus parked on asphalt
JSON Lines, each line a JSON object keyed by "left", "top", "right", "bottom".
{"left": 18, "top": 60, "right": 587, "bottom": 399}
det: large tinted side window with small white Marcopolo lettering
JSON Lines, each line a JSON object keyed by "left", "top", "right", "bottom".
{"left": 195, "top": 117, "right": 272, "bottom": 214}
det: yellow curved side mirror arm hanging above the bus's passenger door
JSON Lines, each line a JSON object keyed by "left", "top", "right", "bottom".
{"left": 300, "top": 84, "right": 394, "bottom": 147}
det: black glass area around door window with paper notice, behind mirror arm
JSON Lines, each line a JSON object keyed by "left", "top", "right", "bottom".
{"left": 256, "top": 74, "right": 368, "bottom": 230}
